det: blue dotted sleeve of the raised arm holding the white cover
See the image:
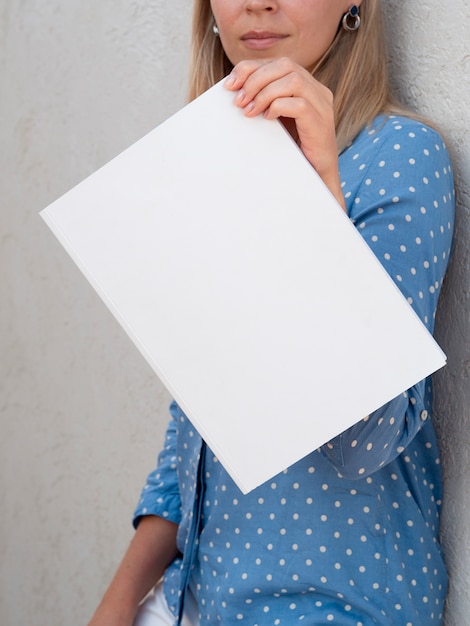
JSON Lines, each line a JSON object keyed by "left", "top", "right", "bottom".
{"left": 322, "top": 118, "right": 454, "bottom": 479}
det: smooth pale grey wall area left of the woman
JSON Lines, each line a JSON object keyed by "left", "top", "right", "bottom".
{"left": 0, "top": 0, "right": 190, "bottom": 626}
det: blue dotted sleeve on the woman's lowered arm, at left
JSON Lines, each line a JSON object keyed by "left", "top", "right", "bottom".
{"left": 133, "top": 402, "right": 181, "bottom": 528}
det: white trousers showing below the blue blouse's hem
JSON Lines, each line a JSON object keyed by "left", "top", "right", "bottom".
{"left": 134, "top": 584, "right": 199, "bottom": 626}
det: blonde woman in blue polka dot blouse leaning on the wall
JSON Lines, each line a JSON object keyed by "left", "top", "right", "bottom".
{"left": 86, "top": 0, "right": 454, "bottom": 626}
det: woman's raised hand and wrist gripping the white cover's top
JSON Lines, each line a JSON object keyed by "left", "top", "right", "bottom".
{"left": 225, "top": 58, "right": 345, "bottom": 209}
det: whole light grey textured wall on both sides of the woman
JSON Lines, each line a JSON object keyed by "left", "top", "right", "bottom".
{"left": 0, "top": 0, "right": 470, "bottom": 626}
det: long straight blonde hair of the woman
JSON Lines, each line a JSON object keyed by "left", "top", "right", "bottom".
{"left": 189, "top": 0, "right": 409, "bottom": 151}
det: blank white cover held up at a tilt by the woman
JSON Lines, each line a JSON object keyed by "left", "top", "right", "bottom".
{"left": 41, "top": 83, "right": 445, "bottom": 493}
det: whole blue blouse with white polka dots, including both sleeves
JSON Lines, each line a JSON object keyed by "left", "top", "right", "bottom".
{"left": 134, "top": 117, "right": 454, "bottom": 626}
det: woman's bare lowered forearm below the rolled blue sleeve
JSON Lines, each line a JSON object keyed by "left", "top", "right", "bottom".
{"left": 88, "top": 515, "right": 178, "bottom": 626}
